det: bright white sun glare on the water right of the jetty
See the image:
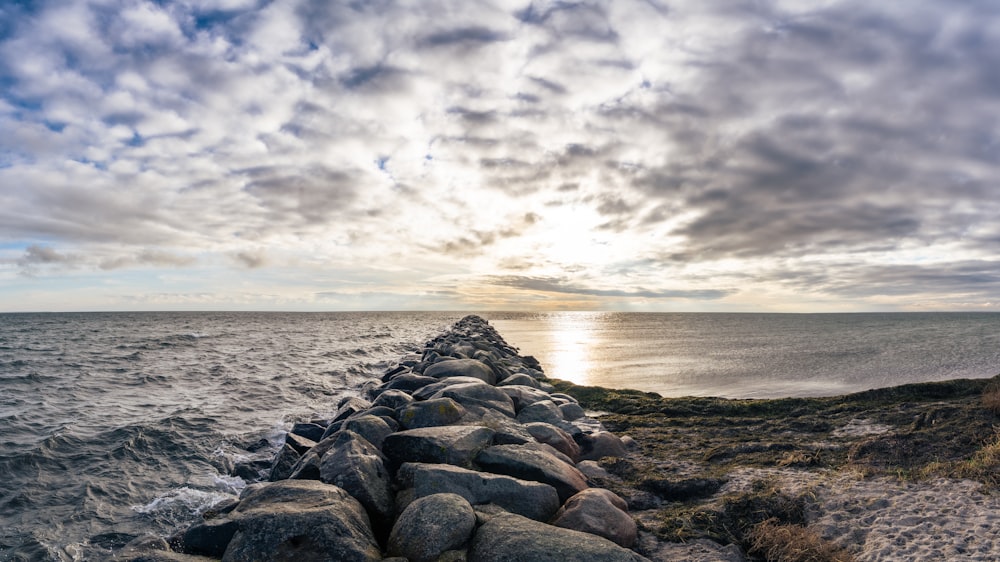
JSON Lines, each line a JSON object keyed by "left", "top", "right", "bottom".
{"left": 543, "top": 312, "right": 598, "bottom": 385}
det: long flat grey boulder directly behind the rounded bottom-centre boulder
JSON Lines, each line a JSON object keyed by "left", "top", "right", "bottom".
{"left": 396, "top": 463, "right": 559, "bottom": 521}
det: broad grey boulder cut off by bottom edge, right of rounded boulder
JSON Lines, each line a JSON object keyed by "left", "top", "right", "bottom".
{"left": 469, "top": 514, "right": 648, "bottom": 562}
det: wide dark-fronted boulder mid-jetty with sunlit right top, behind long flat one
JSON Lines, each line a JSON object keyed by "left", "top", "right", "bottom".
{"left": 382, "top": 425, "right": 493, "bottom": 467}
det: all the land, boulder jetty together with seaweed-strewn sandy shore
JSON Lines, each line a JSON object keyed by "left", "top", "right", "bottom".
{"left": 115, "top": 316, "right": 1000, "bottom": 562}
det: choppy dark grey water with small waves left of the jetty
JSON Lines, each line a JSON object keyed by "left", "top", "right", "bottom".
{"left": 0, "top": 313, "right": 462, "bottom": 560}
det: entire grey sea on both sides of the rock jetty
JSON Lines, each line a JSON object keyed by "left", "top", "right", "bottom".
{"left": 0, "top": 312, "right": 1000, "bottom": 561}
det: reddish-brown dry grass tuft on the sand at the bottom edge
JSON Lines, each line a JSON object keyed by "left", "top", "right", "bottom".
{"left": 747, "top": 518, "right": 853, "bottom": 562}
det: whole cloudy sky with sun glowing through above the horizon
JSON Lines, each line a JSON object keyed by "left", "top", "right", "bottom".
{"left": 0, "top": 0, "right": 1000, "bottom": 311}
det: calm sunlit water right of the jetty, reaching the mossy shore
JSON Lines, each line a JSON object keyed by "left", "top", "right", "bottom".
{"left": 487, "top": 312, "right": 1000, "bottom": 398}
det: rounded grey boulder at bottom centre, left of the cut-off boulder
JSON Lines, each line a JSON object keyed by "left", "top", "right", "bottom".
{"left": 389, "top": 494, "right": 476, "bottom": 562}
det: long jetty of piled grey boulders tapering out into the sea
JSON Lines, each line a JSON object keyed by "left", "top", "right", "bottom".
{"left": 118, "top": 316, "right": 646, "bottom": 562}
